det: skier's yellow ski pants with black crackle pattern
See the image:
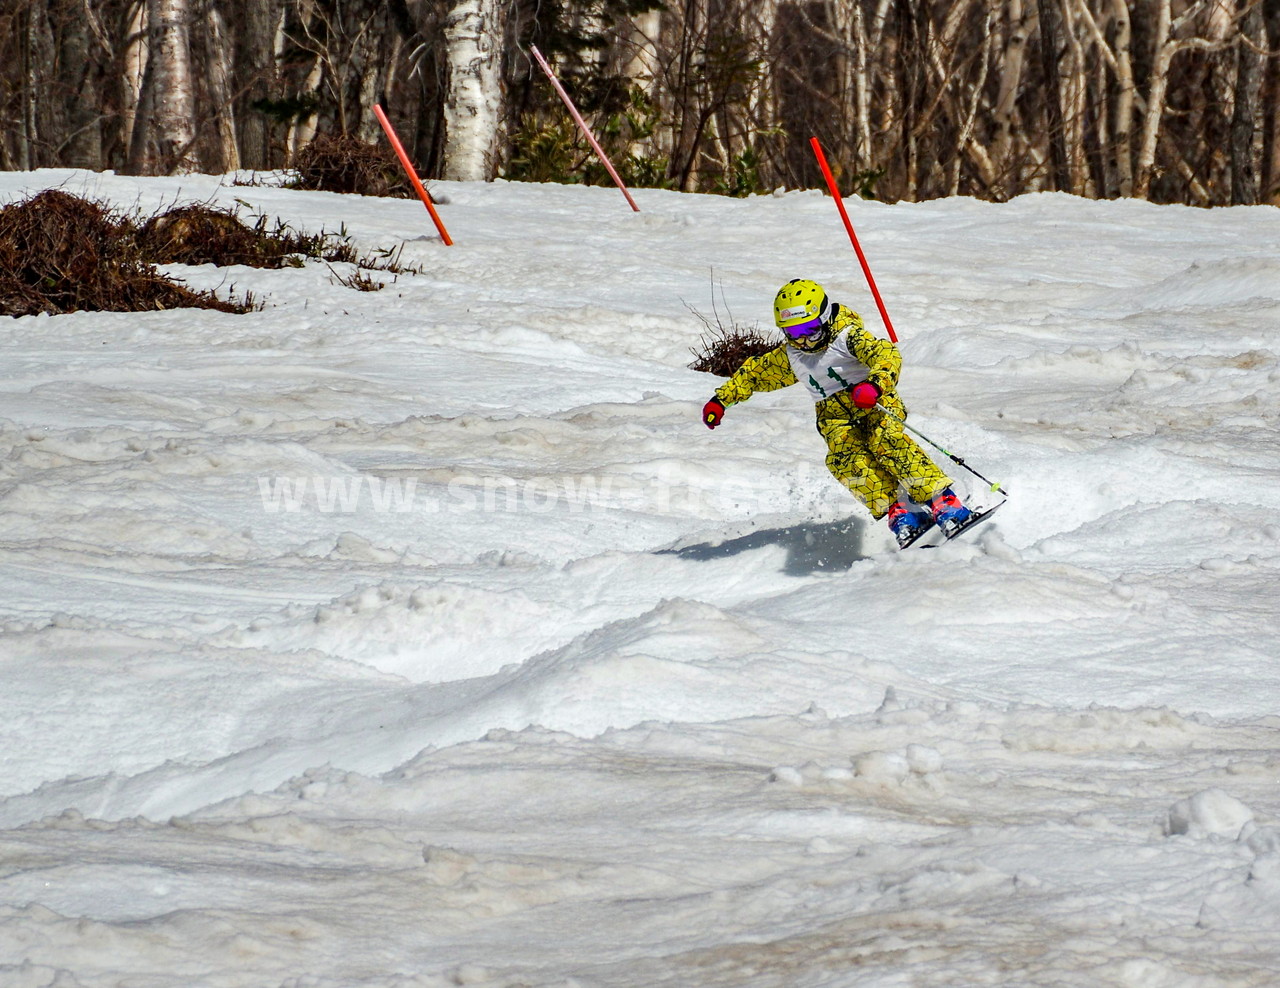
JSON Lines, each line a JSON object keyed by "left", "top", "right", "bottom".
{"left": 818, "top": 394, "right": 951, "bottom": 518}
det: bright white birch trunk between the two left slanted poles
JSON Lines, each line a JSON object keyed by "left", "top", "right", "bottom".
{"left": 444, "top": 0, "right": 506, "bottom": 182}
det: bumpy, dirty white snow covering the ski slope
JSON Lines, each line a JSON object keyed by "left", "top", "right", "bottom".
{"left": 0, "top": 171, "right": 1280, "bottom": 988}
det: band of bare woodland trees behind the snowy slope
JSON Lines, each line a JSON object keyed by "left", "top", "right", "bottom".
{"left": 0, "top": 0, "right": 1280, "bottom": 205}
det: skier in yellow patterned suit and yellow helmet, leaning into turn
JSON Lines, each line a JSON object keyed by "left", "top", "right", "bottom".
{"left": 703, "top": 279, "right": 970, "bottom": 546}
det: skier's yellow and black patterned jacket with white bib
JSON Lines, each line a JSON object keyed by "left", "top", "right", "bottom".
{"left": 716, "top": 305, "right": 902, "bottom": 419}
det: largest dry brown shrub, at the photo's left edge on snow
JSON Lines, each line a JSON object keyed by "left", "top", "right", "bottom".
{"left": 0, "top": 189, "right": 252, "bottom": 316}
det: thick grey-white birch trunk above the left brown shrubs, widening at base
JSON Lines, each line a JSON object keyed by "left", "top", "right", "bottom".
{"left": 129, "top": 0, "right": 198, "bottom": 175}
